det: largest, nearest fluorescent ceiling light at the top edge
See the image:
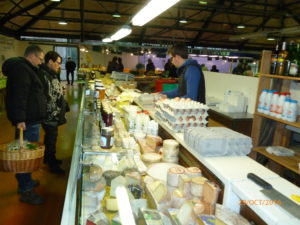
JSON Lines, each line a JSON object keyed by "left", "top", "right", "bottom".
{"left": 132, "top": 0, "right": 180, "bottom": 26}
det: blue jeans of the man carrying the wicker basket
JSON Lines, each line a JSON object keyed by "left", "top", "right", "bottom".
{"left": 15, "top": 124, "right": 40, "bottom": 192}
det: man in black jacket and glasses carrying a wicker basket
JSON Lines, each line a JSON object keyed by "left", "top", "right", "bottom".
{"left": 2, "top": 45, "right": 46, "bottom": 205}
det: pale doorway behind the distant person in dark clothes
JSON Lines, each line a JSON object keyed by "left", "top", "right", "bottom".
{"left": 54, "top": 46, "right": 79, "bottom": 81}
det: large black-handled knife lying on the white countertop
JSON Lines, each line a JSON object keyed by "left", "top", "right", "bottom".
{"left": 247, "top": 173, "right": 300, "bottom": 219}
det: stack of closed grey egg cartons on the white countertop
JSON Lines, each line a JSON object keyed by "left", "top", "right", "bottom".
{"left": 184, "top": 127, "right": 252, "bottom": 156}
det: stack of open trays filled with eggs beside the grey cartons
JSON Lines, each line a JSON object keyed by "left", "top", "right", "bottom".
{"left": 155, "top": 98, "right": 208, "bottom": 132}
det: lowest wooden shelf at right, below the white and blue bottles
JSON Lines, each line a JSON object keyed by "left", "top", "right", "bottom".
{"left": 252, "top": 147, "right": 300, "bottom": 175}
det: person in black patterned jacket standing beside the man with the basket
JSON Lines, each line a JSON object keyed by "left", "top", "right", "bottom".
{"left": 41, "top": 51, "right": 68, "bottom": 174}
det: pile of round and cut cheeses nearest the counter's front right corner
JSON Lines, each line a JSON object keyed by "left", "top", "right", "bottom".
{"left": 144, "top": 167, "right": 220, "bottom": 224}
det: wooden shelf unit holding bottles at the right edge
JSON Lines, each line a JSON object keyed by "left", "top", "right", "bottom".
{"left": 251, "top": 51, "right": 300, "bottom": 181}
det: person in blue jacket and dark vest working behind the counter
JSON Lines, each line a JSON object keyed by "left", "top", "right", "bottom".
{"left": 160, "top": 44, "right": 205, "bottom": 104}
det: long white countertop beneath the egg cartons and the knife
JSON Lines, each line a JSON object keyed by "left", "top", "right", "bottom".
{"left": 136, "top": 102, "right": 300, "bottom": 225}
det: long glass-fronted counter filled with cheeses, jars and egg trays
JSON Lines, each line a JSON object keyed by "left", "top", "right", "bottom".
{"left": 61, "top": 81, "right": 300, "bottom": 225}
